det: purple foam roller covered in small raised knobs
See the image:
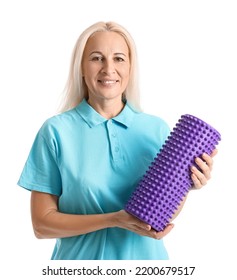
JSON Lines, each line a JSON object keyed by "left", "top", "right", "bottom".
{"left": 125, "top": 114, "right": 221, "bottom": 231}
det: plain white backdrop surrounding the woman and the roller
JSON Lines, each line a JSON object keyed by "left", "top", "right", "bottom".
{"left": 0, "top": 0, "right": 237, "bottom": 279}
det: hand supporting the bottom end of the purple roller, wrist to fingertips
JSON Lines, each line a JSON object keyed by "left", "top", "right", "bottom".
{"left": 114, "top": 210, "right": 174, "bottom": 239}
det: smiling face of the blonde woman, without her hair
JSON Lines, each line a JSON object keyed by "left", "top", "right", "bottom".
{"left": 82, "top": 31, "right": 130, "bottom": 101}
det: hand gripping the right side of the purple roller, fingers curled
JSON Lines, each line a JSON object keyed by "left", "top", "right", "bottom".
{"left": 191, "top": 149, "right": 217, "bottom": 189}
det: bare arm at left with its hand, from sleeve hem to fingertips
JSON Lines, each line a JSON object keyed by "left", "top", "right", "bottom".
{"left": 31, "top": 191, "right": 173, "bottom": 239}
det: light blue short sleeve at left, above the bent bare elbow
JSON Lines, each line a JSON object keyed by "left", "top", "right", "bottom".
{"left": 17, "top": 123, "right": 62, "bottom": 196}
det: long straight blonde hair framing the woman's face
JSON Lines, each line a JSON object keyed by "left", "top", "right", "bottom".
{"left": 59, "top": 22, "right": 141, "bottom": 112}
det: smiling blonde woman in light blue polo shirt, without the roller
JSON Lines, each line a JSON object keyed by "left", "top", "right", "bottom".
{"left": 18, "top": 22, "right": 216, "bottom": 260}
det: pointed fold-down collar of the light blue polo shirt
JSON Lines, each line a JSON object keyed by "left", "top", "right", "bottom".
{"left": 76, "top": 99, "right": 136, "bottom": 127}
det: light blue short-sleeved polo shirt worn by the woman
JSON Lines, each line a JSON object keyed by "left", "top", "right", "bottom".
{"left": 18, "top": 100, "right": 170, "bottom": 260}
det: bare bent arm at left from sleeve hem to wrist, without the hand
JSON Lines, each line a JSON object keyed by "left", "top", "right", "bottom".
{"left": 31, "top": 191, "right": 115, "bottom": 238}
